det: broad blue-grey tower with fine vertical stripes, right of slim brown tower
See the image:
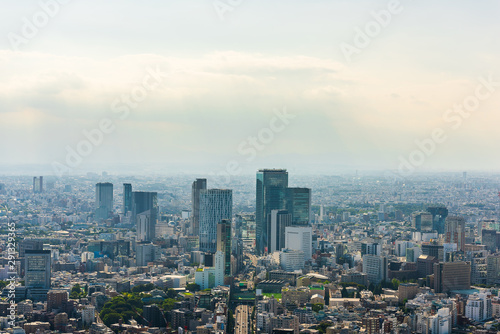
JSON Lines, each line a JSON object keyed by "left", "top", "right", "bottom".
{"left": 200, "top": 189, "right": 233, "bottom": 253}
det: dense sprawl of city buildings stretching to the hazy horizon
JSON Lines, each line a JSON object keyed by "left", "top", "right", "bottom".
{"left": 0, "top": 164, "right": 500, "bottom": 334}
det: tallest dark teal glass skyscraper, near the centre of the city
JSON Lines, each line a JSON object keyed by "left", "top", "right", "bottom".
{"left": 255, "top": 169, "right": 288, "bottom": 254}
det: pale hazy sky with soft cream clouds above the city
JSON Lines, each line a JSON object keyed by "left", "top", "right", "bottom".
{"left": 0, "top": 0, "right": 500, "bottom": 175}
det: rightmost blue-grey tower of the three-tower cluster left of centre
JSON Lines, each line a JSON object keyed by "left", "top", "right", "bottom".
{"left": 130, "top": 191, "right": 158, "bottom": 241}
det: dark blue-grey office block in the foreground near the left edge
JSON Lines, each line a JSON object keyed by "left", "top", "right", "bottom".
{"left": 24, "top": 249, "right": 51, "bottom": 290}
